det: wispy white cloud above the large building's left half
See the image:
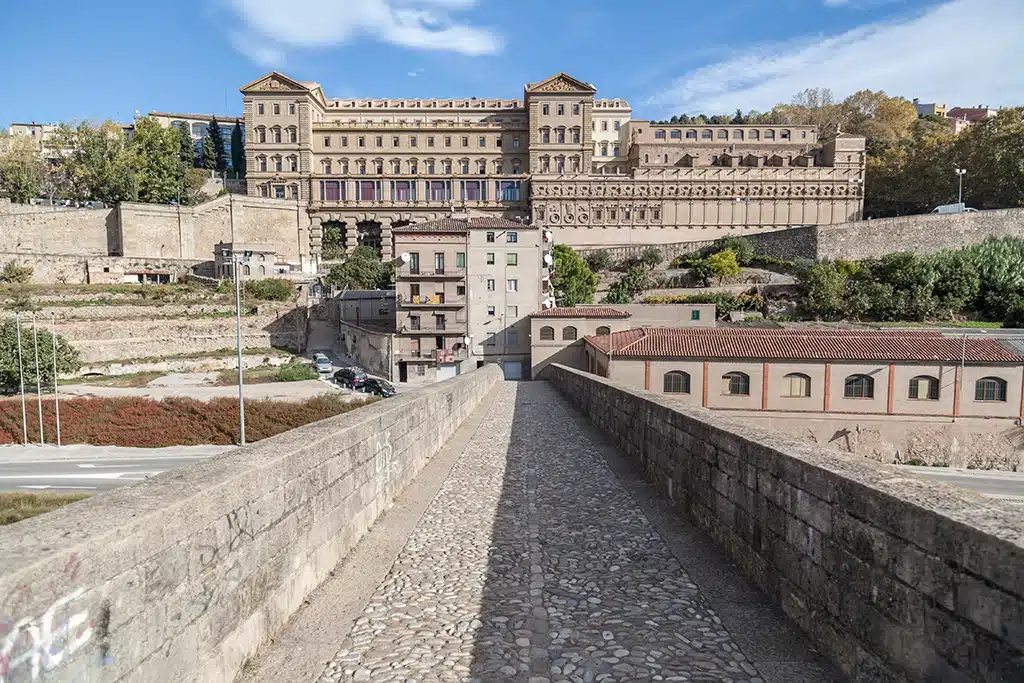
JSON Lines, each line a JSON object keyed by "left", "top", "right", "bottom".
{"left": 226, "top": 0, "right": 503, "bottom": 66}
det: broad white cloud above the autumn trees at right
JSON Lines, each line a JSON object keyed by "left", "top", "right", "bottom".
{"left": 647, "top": 0, "right": 1024, "bottom": 114}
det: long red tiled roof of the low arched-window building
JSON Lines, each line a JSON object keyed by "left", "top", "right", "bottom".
{"left": 587, "top": 328, "right": 1024, "bottom": 364}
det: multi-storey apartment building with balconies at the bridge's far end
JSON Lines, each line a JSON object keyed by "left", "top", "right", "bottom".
{"left": 393, "top": 214, "right": 551, "bottom": 382}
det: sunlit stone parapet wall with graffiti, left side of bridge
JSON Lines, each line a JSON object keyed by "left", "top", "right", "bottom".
{"left": 0, "top": 368, "right": 501, "bottom": 683}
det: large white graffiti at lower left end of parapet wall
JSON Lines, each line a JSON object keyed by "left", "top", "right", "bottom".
{"left": 0, "top": 588, "right": 94, "bottom": 683}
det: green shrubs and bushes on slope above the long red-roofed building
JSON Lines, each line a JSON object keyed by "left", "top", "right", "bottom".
{"left": 553, "top": 237, "right": 1024, "bottom": 328}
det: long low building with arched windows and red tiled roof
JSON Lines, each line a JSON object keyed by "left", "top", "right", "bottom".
{"left": 586, "top": 328, "right": 1024, "bottom": 419}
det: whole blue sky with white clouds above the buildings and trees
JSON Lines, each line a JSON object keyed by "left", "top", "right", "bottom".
{"left": 0, "top": 0, "right": 1024, "bottom": 125}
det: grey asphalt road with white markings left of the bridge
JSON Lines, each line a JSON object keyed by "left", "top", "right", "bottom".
{"left": 0, "top": 445, "right": 234, "bottom": 494}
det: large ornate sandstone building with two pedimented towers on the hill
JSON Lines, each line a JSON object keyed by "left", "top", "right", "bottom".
{"left": 242, "top": 72, "right": 864, "bottom": 256}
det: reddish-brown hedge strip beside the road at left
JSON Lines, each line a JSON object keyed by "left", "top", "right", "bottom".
{"left": 0, "top": 393, "right": 375, "bottom": 449}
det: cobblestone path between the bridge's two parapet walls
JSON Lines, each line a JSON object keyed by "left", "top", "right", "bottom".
{"left": 318, "top": 382, "right": 762, "bottom": 683}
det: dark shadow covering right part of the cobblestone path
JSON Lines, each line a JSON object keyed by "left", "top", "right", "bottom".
{"left": 468, "top": 382, "right": 762, "bottom": 683}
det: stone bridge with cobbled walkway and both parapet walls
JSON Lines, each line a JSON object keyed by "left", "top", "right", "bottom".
{"left": 0, "top": 366, "right": 1024, "bottom": 683}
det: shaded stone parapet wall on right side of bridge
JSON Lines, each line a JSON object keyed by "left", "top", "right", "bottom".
{"left": 546, "top": 366, "right": 1024, "bottom": 683}
